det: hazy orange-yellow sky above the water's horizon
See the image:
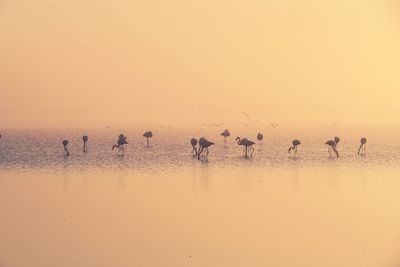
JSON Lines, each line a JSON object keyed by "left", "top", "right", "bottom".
{"left": 0, "top": 0, "right": 400, "bottom": 128}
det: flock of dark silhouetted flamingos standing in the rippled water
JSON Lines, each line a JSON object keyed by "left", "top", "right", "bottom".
{"left": 51, "top": 130, "right": 367, "bottom": 160}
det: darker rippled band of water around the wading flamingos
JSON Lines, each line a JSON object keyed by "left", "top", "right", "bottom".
{"left": 0, "top": 129, "right": 400, "bottom": 172}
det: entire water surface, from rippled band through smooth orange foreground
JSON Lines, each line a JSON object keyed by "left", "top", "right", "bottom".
{"left": 0, "top": 130, "right": 400, "bottom": 267}
